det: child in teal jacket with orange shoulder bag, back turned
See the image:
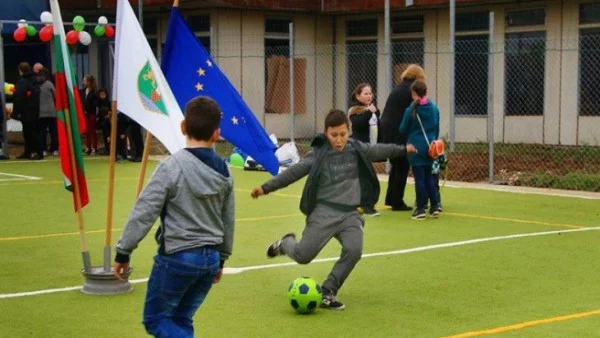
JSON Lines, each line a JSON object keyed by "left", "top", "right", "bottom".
{"left": 400, "top": 80, "right": 440, "bottom": 220}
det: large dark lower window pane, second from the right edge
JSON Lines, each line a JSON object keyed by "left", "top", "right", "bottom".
{"left": 504, "top": 32, "right": 546, "bottom": 115}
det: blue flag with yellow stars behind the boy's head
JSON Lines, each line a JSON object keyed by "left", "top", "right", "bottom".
{"left": 161, "top": 7, "right": 279, "bottom": 175}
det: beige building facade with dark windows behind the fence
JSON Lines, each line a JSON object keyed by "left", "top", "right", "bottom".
{"left": 63, "top": 0, "right": 600, "bottom": 146}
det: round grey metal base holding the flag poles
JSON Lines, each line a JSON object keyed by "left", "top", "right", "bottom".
{"left": 81, "top": 266, "right": 133, "bottom": 295}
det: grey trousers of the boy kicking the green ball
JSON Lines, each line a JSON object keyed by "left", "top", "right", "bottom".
{"left": 281, "top": 205, "right": 364, "bottom": 294}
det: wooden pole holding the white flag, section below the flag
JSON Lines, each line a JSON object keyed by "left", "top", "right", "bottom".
{"left": 104, "top": 100, "right": 118, "bottom": 272}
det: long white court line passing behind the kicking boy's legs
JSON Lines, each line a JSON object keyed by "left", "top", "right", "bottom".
{"left": 0, "top": 227, "right": 600, "bottom": 299}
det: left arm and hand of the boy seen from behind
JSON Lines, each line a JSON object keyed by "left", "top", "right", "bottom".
{"left": 115, "top": 162, "right": 171, "bottom": 263}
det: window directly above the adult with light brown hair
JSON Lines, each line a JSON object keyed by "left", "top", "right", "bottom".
{"left": 391, "top": 17, "right": 425, "bottom": 86}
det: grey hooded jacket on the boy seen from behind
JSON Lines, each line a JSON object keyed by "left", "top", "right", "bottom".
{"left": 116, "top": 149, "right": 235, "bottom": 260}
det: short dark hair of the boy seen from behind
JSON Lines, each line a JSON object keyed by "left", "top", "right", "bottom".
{"left": 184, "top": 96, "right": 221, "bottom": 141}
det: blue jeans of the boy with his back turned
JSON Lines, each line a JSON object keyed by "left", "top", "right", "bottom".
{"left": 144, "top": 247, "right": 221, "bottom": 338}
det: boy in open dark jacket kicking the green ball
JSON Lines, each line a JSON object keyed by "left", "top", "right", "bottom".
{"left": 251, "top": 110, "right": 415, "bottom": 310}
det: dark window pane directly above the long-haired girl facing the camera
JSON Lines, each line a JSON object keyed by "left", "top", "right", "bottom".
{"left": 346, "top": 41, "right": 377, "bottom": 105}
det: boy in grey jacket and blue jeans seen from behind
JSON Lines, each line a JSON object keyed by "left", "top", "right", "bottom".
{"left": 114, "top": 96, "right": 234, "bottom": 337}
